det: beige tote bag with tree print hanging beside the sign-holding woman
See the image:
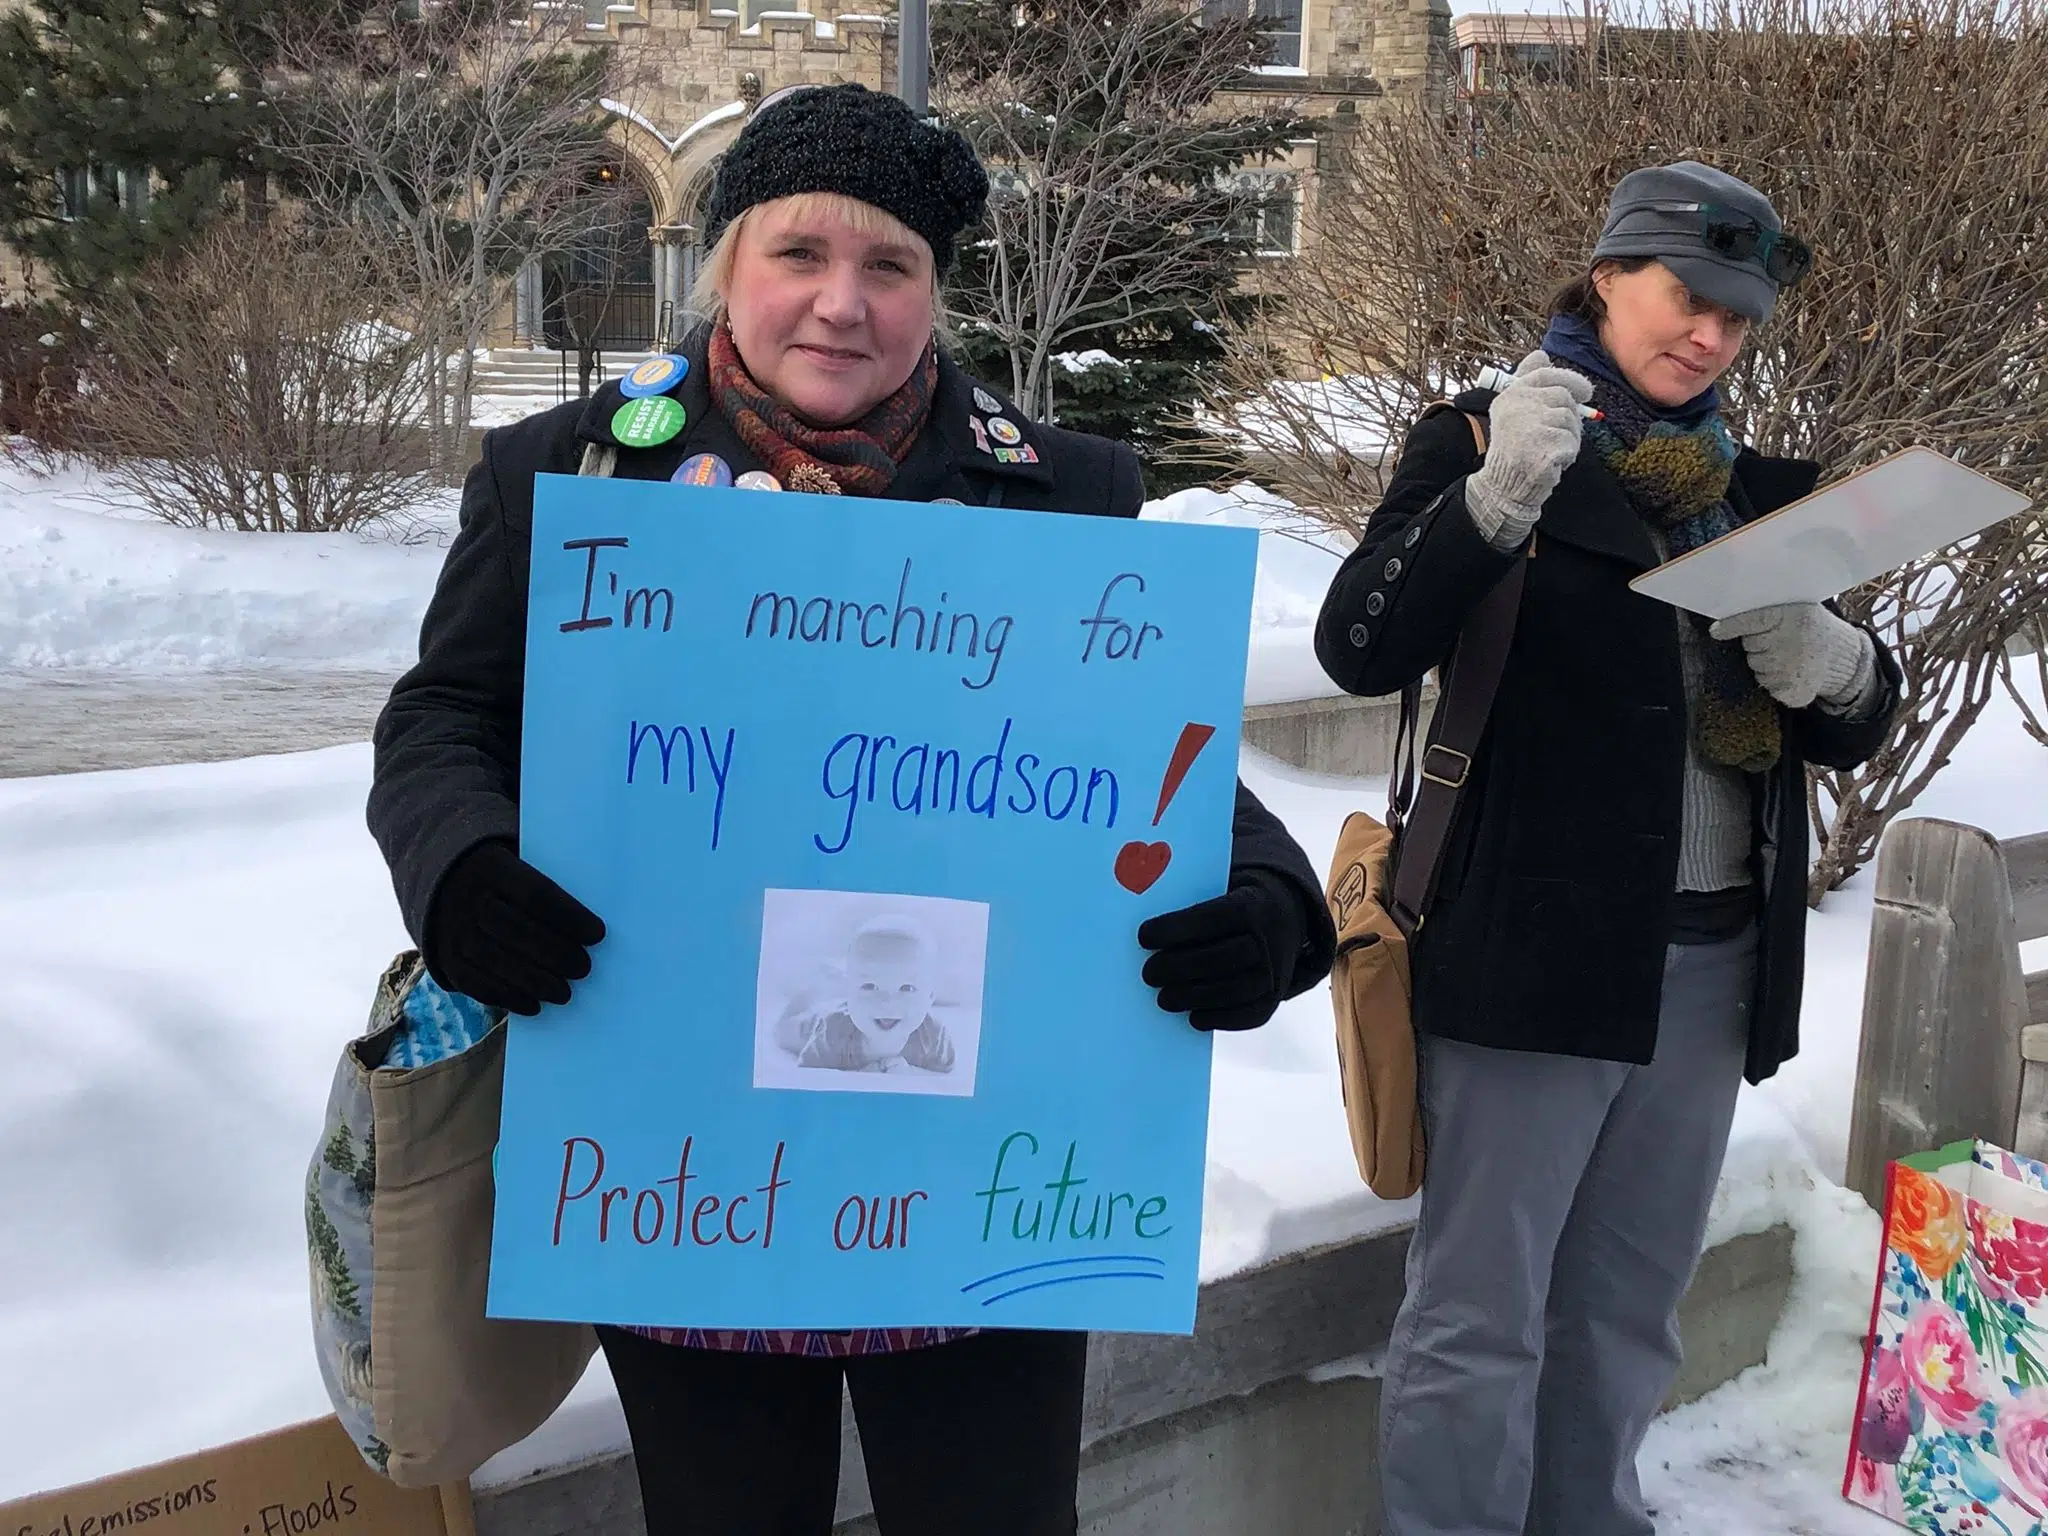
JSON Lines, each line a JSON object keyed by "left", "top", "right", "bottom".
{"left": 305, "top": 444, "right": 616, "bottom": 1489}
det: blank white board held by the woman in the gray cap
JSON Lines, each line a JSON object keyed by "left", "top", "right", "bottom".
{"left": 1628, "top": 449, "right": 2030, "bottom": 618}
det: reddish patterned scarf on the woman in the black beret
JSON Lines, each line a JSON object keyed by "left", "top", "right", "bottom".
{"left": 707, "top": 324, "right": 938, "bottom": 496}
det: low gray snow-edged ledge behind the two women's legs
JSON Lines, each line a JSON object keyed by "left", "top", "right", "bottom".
{"left": 477, "top": 1227, "right": 1792, "bottom": 1536}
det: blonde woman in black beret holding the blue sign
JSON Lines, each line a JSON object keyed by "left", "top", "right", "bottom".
{"left": 369, "top": 86, "right": 1333, "bottom": 1536}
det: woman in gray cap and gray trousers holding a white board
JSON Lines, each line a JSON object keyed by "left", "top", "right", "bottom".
{"left": 1317, "top": 162, "right": 1898, "bottom": 1536}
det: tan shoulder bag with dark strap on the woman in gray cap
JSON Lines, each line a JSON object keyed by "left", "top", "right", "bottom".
{"left": 1325, "top": 406, "right": 1536, "bottom": 1200}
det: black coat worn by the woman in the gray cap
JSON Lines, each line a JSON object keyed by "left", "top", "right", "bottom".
{"left": 1315, "top": 391, "right": 1901, "bottom": 1081}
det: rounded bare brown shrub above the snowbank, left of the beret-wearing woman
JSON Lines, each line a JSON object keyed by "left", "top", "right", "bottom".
{"left": 80, "top": 219, "right": 432, "bottom": 532}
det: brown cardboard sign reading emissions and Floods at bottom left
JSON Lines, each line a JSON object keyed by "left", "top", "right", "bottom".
{"left": 0, "top": 1415, "right": 475, "bottom": 1536}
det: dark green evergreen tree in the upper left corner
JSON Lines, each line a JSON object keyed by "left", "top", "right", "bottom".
{"left": 0, "top": 0, "right": 266, "bottom": 305}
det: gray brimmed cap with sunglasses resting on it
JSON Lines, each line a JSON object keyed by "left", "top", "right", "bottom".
{"left": 1593, "top": 160, "right": 1784, "bottom": 326}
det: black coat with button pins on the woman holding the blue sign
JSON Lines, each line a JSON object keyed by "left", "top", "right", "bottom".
{"left": 369, "top": 332, "right": 1335, "bottom": 995}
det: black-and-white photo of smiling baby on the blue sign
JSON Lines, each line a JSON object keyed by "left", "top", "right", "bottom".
{"left": 754, "top": 891, "right": 989, "bottom": 1098}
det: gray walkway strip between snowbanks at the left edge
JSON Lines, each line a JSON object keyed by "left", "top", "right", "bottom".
{"left": 0, "top": 668, "right": 391, "bottom": 778}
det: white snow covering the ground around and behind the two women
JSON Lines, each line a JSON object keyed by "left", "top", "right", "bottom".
{"left": 0, "top": 456, "right": 2048, "bottom": 1536}
